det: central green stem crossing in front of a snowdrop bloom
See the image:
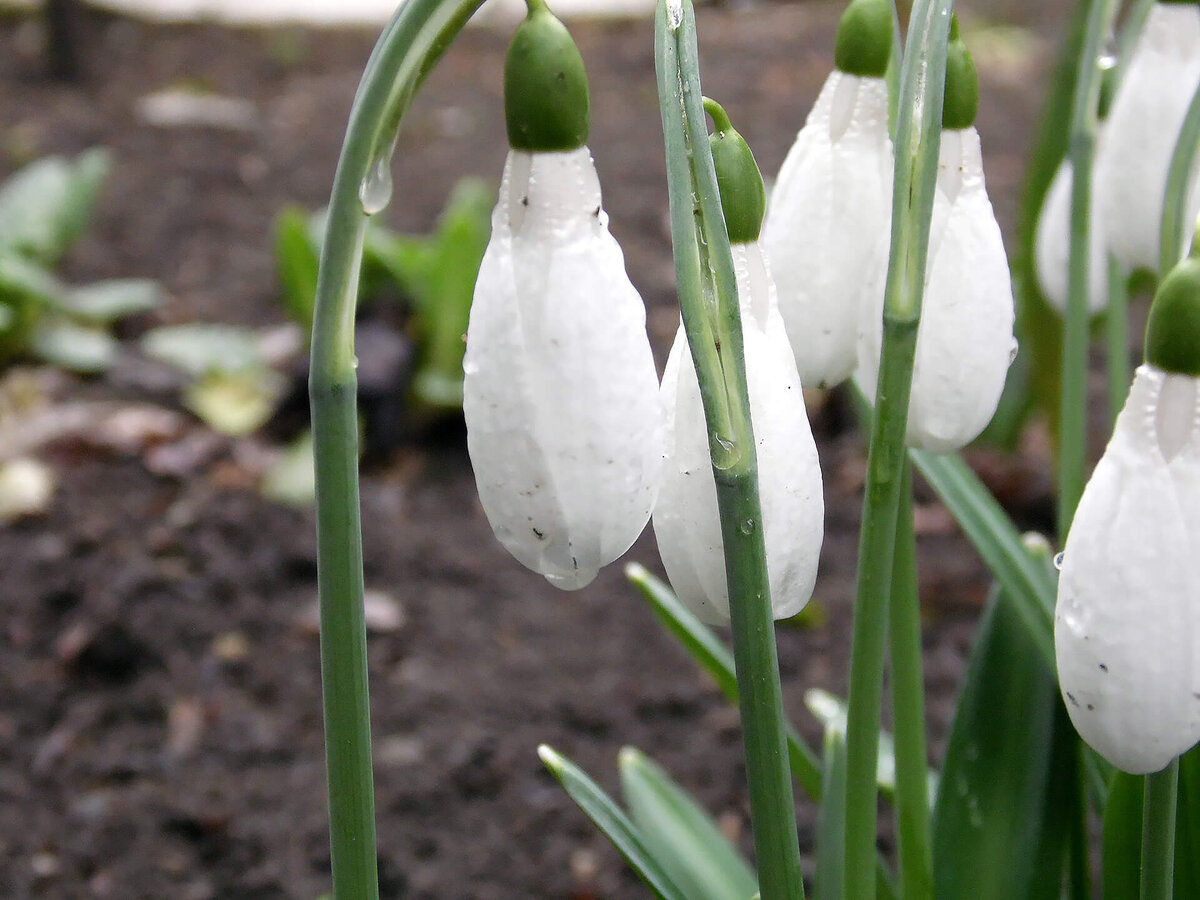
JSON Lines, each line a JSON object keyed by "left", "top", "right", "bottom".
{"left": 654, "top": 0, "right": 801, "bottom": 900}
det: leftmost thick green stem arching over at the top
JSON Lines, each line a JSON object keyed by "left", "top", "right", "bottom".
{"left": 308, "top": 0, "right": 482, "bottom": 900}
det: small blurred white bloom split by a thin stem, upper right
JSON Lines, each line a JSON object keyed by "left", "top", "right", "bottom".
{"left": 1034, "top": 122, "right": 1109, "bottom": 316}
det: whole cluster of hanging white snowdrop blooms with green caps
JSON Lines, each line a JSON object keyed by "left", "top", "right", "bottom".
{"left": 464, "top": 0, "right": 1200, "bottom": 787}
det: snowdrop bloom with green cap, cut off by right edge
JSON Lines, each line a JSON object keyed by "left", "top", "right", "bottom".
{"left": 1055, "top": 259, "right": 1200, "bottom": 775}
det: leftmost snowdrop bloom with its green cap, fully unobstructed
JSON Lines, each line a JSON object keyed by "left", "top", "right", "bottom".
{"left": 463, "top": 0, "right": 662, "bottom": 589}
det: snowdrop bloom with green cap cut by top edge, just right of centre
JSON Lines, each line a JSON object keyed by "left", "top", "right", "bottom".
{"left": 763, "top": 0, "right": 893, "bottom": 388}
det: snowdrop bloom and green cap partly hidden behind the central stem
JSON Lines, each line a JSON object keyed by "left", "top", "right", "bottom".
{"left": 654, "top": 101, "right": 824, "bottom": 624}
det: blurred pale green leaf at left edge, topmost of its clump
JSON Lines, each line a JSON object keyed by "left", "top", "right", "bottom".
{"left": 0, "top": 149, "right": 109, "bottom": 265}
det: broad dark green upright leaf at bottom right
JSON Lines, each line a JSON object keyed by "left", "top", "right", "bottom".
{"left": 934, "top": 592, "right": 1062, "bottom": 900}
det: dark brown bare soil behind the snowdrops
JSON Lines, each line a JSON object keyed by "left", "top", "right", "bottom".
{"left": 0, "top": 2, "right": 1064, "bottom": 900}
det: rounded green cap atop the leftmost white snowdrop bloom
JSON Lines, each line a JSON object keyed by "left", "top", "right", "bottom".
{"left": 504, "top": 0, "right": 588, "bottom": 152}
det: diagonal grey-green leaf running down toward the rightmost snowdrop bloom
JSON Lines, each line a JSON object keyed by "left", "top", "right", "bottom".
{"left": 908, "top": 450, "right": 1057, "bottom": 673}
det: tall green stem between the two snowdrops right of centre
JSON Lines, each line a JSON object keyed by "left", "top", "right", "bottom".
{"left": 842, "top": 0, "right": 953, "bottom": 900}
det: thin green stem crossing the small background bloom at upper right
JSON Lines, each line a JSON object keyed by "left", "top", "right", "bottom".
{"left": 1058, "top": 0, "right": 1116, "bottom": 542}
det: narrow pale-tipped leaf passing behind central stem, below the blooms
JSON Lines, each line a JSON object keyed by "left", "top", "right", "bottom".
{"left": 625, "top": 563, "right": 821, "bottom": 800}
